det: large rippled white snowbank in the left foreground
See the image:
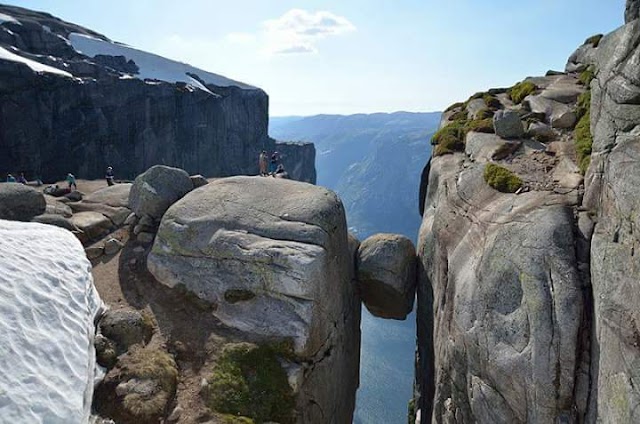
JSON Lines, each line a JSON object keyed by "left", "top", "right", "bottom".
{"left": 0, "top": 220, "right": 103, "bottom": 424}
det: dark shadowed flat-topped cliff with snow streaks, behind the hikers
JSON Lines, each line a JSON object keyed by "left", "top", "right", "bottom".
{"left": 0, "top": 6, "right": 315, "bottom": 182}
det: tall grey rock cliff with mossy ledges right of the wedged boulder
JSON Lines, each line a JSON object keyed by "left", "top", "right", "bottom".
{"left": 412, "top": 1, "right": 640, "bottom": 423}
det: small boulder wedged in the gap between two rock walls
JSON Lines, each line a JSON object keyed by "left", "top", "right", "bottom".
{"left": 356, "top": 234, "right": 416, "bottom": 320}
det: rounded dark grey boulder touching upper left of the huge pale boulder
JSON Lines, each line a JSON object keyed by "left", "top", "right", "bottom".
{"left": 129, "top": 165, "right": 193, "bottom": 220}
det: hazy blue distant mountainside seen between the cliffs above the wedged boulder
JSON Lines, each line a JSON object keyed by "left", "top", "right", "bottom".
{"left": 269, "top": 112, "right": 440, "bottom": 240}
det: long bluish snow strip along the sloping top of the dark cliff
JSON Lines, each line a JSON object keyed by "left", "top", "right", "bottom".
{"left": 69, "top": 33, "right": 256, "bottom": 93}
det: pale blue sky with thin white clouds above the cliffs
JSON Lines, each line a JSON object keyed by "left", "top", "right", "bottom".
{"left": 3, "top": 0, "right": 625, "bottom": 116}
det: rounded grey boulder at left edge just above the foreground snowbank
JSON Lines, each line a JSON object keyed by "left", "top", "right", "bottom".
{"left": 0, "top": 183, "right": 47, "bottom": 221}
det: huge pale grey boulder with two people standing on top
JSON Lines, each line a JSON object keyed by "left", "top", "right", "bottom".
{"left": 147, "top": 177, "right": 360, "bottom": 423}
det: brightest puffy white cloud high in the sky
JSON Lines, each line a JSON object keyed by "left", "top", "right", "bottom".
{"left": 263, "top": 9, "right": 356, "bottom": 54}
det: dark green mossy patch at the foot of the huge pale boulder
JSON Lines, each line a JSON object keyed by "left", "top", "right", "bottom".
{"left": 207, "top": 343, "right": 294, "bottom": 424}
